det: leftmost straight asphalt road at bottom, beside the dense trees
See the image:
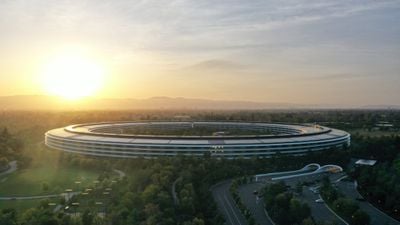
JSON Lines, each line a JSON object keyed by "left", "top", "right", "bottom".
{"left": 211, "top": 180, "right": 247, "bottom": 225}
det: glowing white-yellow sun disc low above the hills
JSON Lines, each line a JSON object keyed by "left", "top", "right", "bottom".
{"left": 42, "top": 54, "right": 104, "bottom": 100}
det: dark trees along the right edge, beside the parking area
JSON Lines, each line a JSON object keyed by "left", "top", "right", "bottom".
{"left": 351, "top": 136, "right": 400, "bottom": 220}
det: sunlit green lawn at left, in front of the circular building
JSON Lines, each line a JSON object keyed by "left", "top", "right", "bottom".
{"left": 0, "top": 165, "right": 101, "bottom": 196}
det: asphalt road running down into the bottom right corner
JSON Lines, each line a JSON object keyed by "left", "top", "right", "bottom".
{"left": 337, "top": 181, "right": 400, "bottom": 225}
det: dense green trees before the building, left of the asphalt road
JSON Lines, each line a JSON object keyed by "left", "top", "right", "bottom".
{"left": 99, "top": 150, "right": 347, "bottom": 225}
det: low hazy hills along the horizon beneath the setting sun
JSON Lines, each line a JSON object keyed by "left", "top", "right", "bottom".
{"left": 0, "top": 95, "right": 315, "bottom": 110}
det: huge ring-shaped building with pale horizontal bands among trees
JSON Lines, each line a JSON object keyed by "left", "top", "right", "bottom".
{"left": 45, "top": 122, "right": 350, "bottom": 158}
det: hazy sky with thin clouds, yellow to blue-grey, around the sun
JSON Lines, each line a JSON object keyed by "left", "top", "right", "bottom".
{"left": 0, "top": 0, "right": 400, "bottom": 105}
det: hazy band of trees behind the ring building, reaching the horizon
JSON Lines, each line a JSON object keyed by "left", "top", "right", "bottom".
{"left": 0, "top": 110, "right": 400, "bottom": 141}
